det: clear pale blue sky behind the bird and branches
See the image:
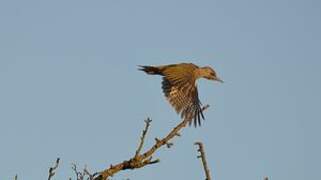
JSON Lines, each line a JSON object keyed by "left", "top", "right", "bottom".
{"left": 0, "top": 0, "right": 321, "bottom": 180}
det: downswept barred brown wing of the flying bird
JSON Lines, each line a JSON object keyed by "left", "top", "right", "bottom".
{"left": 162, "top": 77, "right": 204, "bottom": 126}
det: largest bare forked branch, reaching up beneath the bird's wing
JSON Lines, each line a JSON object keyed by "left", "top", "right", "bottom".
{"left": 94, "top": 105, "right": 209, "bottom": 180}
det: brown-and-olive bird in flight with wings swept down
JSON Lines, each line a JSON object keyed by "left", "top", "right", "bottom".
{"left": 139, "top": 63, "right": 223, "bottom": 127}
